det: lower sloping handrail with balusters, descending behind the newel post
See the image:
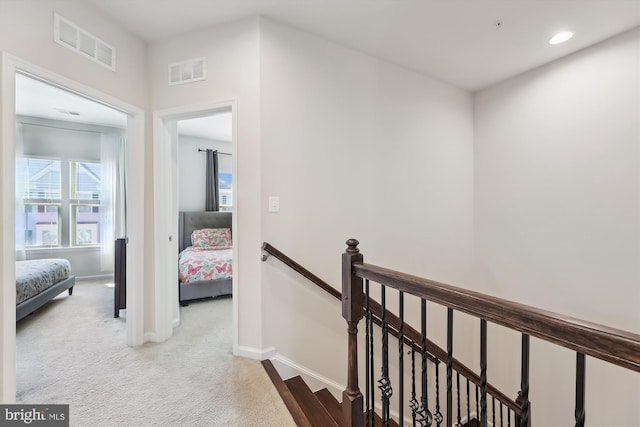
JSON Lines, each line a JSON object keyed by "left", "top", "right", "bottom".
{"left": 262, "top": 242, "right": 521, "bottom": 426}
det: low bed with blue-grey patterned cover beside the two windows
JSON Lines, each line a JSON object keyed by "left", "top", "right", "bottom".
{"left": 16, "top": 258, "right": 75, "bottom": 321}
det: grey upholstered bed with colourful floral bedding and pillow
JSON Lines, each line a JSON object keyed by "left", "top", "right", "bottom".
{"left": 178, "top": 212, "right": 233, "bottom": 306}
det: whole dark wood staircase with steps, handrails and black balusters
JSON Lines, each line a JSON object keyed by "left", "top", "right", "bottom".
{"left": 263, "top": 239, "right": 640, "bottom": 427}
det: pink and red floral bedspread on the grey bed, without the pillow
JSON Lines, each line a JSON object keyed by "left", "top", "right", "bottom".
{"left": 178, "top": 246, "right": 233, "bottom": 283}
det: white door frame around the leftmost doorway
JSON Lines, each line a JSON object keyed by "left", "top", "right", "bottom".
{"left": 0, "top": 52, "right": 145, "bottom": 403}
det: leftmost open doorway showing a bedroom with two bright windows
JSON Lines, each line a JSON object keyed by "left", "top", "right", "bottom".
{"left": 15, "top": 71, "right": 128, "bottom": 401}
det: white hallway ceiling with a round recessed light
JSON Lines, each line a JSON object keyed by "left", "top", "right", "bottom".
{"left": 90, "top": 0, "right": 640, "bottom": 91}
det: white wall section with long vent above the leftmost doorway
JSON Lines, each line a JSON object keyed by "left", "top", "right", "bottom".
{"left": 0, "top": 0, "right": 147, "bottom": 108}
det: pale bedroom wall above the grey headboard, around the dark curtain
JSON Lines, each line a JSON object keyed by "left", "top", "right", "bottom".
{"left": 178, "top": 135, "right": 232, "bottom": 211}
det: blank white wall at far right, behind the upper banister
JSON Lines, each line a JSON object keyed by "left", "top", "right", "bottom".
{"left": 475, "top": 29, "right": 640, "bottom": 426}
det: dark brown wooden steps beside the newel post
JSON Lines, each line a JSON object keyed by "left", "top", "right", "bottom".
{"left": 262, "top": 360, "right": 399, "bottom": 427}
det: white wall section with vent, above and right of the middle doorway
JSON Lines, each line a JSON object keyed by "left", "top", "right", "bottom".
{"left": 149, "top": 18, "right": 263, "bottom": 352}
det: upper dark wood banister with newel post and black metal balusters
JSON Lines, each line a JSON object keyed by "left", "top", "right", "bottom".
{"left": 342, "top": 239, "right": 640, "bottom": 427}
